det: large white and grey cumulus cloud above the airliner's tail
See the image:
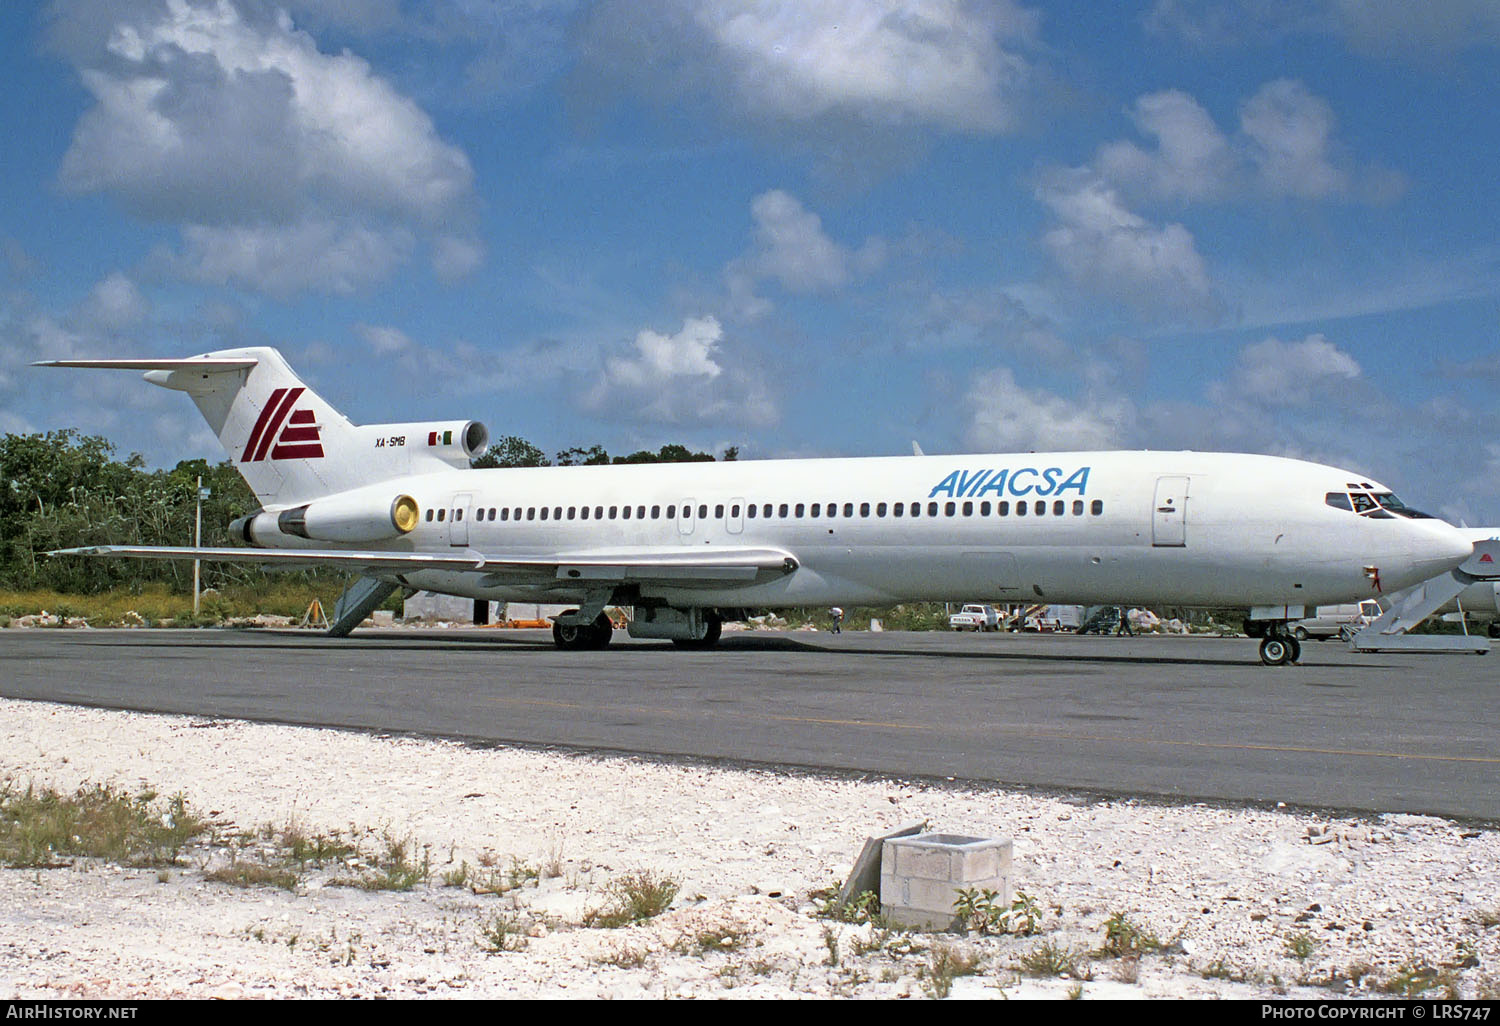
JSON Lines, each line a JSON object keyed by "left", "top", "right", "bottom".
{"left": 53, "top": 0, "right": 477, "bottom": 294}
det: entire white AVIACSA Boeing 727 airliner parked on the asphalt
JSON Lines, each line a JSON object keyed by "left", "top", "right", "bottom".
{"left": 41, "top": 348, "right": 1473, "bottom": 665}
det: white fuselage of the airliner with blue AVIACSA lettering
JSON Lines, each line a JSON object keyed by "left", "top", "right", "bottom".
{"left": 257, "top": 452, "right": 1470, "bottom": 608}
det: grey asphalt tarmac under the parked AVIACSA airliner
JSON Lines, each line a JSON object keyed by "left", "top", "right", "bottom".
{"left": 0, "top": 629, "right": 1500, "bottom": 822}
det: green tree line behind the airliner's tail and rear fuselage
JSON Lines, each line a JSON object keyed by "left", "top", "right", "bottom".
{"left": 0, "top": 429, "right": 740, "bottom": 594}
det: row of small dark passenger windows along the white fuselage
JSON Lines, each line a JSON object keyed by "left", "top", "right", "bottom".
{"left": 428, "top": 500, "right": 1104, "bottom": 522}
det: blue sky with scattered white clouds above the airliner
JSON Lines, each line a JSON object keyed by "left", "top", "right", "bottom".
{"left": 0, "top": 0, "right": 1500, "bottom": 524}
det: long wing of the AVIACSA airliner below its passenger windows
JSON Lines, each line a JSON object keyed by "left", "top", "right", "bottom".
{"left": 47, "top": 545, "right": 798, "bottom": 588}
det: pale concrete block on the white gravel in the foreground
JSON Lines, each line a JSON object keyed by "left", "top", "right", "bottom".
{"left": 881, "top": 833, "right": 1011, "bottom": 930}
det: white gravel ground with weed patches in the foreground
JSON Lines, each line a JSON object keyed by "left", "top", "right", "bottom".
{"left": 0, "top": 701, "right": 1500, "bottom": 999}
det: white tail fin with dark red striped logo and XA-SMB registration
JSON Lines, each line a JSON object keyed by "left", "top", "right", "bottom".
{"left": 39, "top": 347, "right": 489, "bottom": 509}
